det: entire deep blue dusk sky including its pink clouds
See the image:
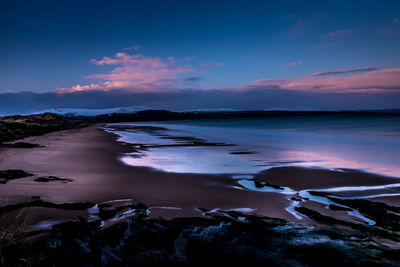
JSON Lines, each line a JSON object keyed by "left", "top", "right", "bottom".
{"left": 0, "top": 0, "right": 400, "bottom": 114}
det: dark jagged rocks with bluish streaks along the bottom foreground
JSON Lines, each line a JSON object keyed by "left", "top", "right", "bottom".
{"left": 0, "top": 199, "right": 400, "bottom": 266}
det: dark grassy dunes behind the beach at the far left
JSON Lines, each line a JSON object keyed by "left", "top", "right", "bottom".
{"left": 0, "top": 113, "right": 86, "bottom": 144}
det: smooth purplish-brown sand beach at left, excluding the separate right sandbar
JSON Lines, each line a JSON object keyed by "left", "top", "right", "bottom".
{"left": 0, "top": 124, "right": 291, "bottom": 222}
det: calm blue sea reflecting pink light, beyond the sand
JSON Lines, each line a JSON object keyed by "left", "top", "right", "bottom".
{"left": 106, "top": 117, "right": 400, "bottom": 177}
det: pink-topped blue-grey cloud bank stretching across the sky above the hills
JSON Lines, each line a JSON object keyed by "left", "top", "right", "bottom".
{"left": 0, "top": 46, "right": 400, "bottom": 115}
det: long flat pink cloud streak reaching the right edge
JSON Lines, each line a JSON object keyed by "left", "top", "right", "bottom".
{"left": 222, "top": 68, "right": 400, "bottom": 93}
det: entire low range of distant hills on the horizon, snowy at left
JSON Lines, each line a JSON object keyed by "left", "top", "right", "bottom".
{"left": 32, "top": 106, "right": 400, "bottom": 122}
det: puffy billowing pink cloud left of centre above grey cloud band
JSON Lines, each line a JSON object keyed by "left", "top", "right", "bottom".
{"left": 57, "top": 52, "right": 221, "bottom": 93}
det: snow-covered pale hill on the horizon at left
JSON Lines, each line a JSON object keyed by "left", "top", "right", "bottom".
{"left": 32, "top": 106, "right": 149, "bottom": 117}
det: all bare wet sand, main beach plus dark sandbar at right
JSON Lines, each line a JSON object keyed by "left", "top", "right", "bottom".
{"left": 0, "top": 124, "right": 400, "bottom": 223}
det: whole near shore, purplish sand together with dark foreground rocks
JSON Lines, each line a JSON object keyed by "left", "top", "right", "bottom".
{"left": 0, "top": 124, "right": 400, "bottom": 266}
